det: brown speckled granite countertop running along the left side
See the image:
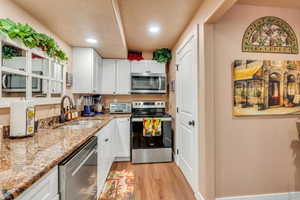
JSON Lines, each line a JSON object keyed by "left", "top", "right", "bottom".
{"left": 0, "top": 114, "right": 130, "bottom": 200}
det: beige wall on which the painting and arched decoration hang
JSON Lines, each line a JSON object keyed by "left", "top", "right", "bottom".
{"left": 213, "top": 5, "right": 300, "bottom": 197}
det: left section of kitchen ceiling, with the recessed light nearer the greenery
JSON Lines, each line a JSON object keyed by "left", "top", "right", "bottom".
{"left": 13, "top": 0, "right": 127, "bottom": 58}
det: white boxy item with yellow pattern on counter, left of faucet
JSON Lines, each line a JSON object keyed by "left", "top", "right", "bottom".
{"left": 9, "top": 100, "right": 35, "bottom": 138}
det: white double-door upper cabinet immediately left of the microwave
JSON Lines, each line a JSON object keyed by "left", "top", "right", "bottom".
{"left": 101, "top": 59, "right": 131, "bottom": 94}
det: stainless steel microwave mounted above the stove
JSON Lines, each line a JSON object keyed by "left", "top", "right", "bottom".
{"left": 131, "top": 73, "right": 167, "bottom": 94}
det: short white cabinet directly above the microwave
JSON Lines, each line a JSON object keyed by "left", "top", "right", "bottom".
{"left": 131, "top": 60, "right": 166, "bottom": 73}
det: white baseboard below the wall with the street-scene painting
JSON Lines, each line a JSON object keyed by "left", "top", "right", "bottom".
{"left": 216, "top": 192, "right": 300, "bottom": 200}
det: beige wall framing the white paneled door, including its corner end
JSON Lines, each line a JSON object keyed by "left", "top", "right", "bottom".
{"left": 169, "top": 0, "right": 236, "bottom": 200}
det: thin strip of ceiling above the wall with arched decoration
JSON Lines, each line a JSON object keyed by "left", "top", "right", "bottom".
{"left": 238, "top": 0, "right": 300, "bottom": 8}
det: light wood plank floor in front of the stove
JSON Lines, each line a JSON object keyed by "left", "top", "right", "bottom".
{"left": 111, "top": 162, "right": 195, "bottom": 200}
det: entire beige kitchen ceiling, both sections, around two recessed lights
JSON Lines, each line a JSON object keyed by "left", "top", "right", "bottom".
{"left": 13, "top": 0, "right": 203, "bottom": 58}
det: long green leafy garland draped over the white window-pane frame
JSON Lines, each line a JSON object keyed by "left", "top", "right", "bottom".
{"left": 0, "top": 19, "right": 68, "bottom": 61}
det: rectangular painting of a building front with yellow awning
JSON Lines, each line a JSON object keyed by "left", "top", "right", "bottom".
{"left": 232, "top": 60, "right": 300, "bottom": 116}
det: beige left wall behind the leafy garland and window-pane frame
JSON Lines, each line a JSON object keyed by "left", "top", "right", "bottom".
{"left": 0, "top": 0, "right": 72, "bottom": 125}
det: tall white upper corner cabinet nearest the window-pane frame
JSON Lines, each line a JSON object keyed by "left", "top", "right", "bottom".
{"left": 73, "top": 47, "right": 101, "bottom": 93}
